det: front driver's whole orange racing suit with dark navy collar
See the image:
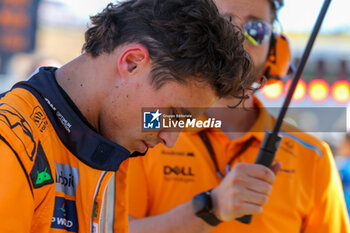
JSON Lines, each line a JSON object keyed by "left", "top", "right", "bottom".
{"left": 0, "top": 67, "right": 142, "bottom": 233}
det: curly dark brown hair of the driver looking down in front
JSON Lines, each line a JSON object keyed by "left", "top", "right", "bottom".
{"left": 83, "top": 0, "right": 254, "bottom": 97}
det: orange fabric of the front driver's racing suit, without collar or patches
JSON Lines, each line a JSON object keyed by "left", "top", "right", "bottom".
{"left": 0, "top": 88, "right": 128, "bottom": 233}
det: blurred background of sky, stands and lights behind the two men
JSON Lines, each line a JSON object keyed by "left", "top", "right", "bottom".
{"left": 0, "top": 0, "right": 350, "bottom": 200}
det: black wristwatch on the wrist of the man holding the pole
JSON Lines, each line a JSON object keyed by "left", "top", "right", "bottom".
{"left": 192, "top": 190, "right": 221, "bottom": 226}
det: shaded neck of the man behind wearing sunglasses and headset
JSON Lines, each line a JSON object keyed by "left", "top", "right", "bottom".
{"left": 206, "top": 95, "right": 259, "bottom": 140}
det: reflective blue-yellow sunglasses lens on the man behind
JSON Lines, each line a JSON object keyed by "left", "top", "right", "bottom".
{"left": 244, "top": 20, "right": 271, "bottom": 45}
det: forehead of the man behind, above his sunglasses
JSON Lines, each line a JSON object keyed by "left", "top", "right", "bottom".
{"left": 215, "top": 0, "right": 272, "bottom": 23}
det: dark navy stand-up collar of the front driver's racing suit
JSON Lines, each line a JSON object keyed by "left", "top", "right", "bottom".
{"left": 14, "top": 67, "right": 145, "bottom": 171}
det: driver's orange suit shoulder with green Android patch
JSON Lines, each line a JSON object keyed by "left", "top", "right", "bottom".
{"left": 0, "top": 89, "right": 53, "bottom": 188}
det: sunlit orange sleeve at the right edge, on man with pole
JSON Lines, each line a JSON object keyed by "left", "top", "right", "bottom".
{"left": 302, "top": 143, "right": 350, "bottom": 233}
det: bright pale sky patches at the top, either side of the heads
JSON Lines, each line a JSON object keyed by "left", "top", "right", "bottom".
{"left": 56, "top": 0, "right": 350, "bottom": 33}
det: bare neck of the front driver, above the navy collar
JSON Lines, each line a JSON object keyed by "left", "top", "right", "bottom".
{"left": 55, "top": 54, "right": 106, "bottom": 131}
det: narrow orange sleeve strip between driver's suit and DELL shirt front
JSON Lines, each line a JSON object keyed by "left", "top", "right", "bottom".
{"left": 128, "top": 155, "right": 149, "bottom": 218}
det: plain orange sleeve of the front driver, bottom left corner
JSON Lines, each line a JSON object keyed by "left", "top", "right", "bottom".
{"left": 0, "top": 135, "right": 34, "bottom": 233}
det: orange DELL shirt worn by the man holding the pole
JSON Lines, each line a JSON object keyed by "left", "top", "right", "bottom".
{"left": 129, "top": 97, "right": 350, "bottom": 233}
